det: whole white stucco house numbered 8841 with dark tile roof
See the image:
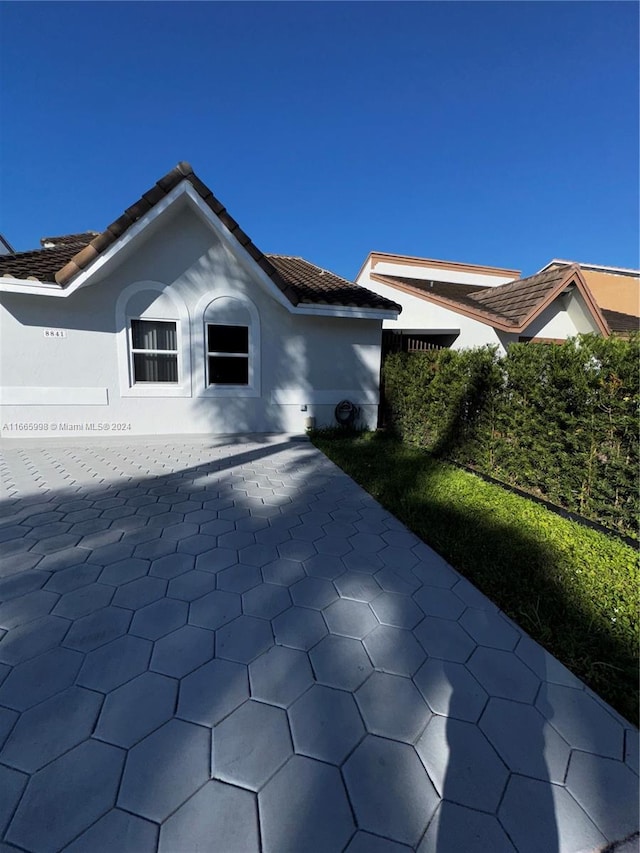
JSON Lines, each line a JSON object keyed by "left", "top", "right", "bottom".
{"left": 0, "top": 163, "right": 401, "bottom": 438}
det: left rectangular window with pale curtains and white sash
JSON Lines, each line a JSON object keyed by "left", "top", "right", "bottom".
{"left": 131, "top": 320, "right": 178, "bottom": 383}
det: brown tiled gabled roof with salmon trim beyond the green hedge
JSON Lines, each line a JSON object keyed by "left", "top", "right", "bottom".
{"left": 371, "top": 267, "right": 609, "bottom": 335}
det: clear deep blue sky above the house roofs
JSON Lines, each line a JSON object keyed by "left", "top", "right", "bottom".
{"left": 0, "top": 2, "right": 640, "bottom": 278}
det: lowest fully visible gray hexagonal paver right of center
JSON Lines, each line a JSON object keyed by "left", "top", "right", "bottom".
{"left": 343, "top": 735, "right": 439, "bottom": 846}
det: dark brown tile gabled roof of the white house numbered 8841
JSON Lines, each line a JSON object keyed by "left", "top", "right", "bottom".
{"left": 0, "top": 162, "right": 402, "bottom": 312}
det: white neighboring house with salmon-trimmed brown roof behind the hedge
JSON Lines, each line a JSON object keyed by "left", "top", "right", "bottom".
{"left": 356, "top": 252, "right": 610, "bottom": 353}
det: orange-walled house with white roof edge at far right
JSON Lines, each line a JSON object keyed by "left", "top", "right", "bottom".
{"left": 540, "top": 258, "right": 640, "bottom": 335}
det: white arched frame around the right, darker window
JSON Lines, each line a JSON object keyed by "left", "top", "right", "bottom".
{"left": 193, "top": 293, "right": 261, "bottom": 397}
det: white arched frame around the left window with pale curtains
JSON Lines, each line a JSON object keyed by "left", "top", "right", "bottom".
{"left": 115, "top": 281, "right": 192, "bottom": 397}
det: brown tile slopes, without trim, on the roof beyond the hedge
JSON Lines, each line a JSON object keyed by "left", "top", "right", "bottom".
{"left": 375, "top": 267, "right": 592, "bottom": 331}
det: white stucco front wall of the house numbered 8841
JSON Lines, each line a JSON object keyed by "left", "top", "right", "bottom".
{"left": 0, "top": 203, "right": 381, "bottom": 438}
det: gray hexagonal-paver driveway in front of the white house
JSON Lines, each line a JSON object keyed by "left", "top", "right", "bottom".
{"left": 0, "top": 437, "right": 638, "bottom": 853}
